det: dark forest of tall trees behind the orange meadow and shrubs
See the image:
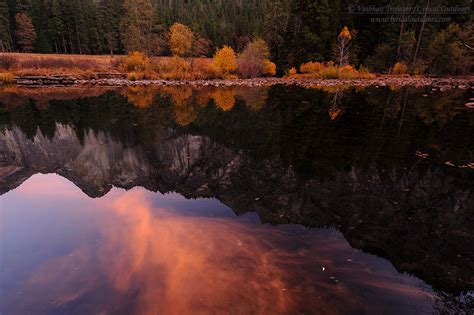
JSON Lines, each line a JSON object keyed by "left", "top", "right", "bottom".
{"left": 0, "top": 0, "right": 474, "bottom": 74}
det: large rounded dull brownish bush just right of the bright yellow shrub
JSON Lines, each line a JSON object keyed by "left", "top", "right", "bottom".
{"left": 237, "top": 39, "right": 276, "bottom": 78}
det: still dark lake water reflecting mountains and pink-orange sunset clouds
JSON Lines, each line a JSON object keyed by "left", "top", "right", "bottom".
{"left": 0, "top": 87, "right": 474, "bottom": 315}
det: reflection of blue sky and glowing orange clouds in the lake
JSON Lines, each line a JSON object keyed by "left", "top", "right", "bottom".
{"left": 0, "top": 175, "right": 435, "bottom": 314}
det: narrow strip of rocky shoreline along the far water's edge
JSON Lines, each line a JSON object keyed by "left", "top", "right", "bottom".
{"left": 14, "top": 74, "right": 474, "bottom": 90}
